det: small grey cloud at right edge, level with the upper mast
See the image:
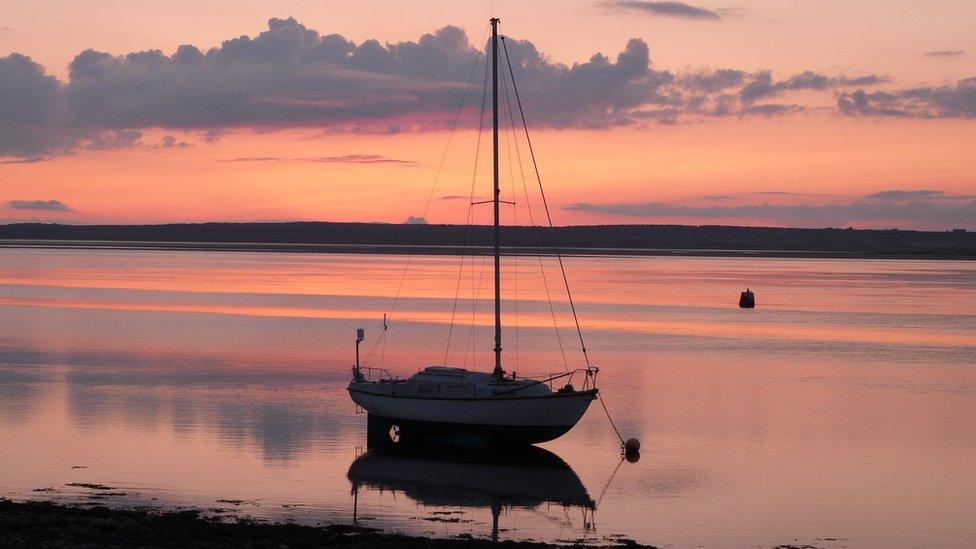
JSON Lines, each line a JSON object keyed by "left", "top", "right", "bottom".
{"left": 837, "top": 78, "right": 976, "bottom": 118}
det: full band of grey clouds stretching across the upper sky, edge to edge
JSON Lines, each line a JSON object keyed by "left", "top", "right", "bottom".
{"left": 0, "top": 17, "right": 976, "bottom": 159}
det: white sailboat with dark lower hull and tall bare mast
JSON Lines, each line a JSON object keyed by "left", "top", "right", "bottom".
{"left": 348, "top": 18, "right": 599, "bottom": 445}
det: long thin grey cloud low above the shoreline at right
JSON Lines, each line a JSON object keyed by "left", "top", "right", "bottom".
{"left": 566, "top": 190, "right": 976, "bottom": 229}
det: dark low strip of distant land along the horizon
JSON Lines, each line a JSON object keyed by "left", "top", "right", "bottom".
{"left": 0, "top": 222, "right": 976, "bottom": 260}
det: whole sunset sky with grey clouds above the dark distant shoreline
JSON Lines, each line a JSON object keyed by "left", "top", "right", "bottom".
{"left": 0, "top": 0, "right": 976, "bottom": 230}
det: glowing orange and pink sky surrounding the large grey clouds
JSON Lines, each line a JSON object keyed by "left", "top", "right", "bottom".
{"left": 0, "top": 1, "right": 976, "bottom": 229}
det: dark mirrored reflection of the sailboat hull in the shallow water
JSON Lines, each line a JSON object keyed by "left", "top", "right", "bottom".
{"left": 347, "top": 442, "right": 596, "bottom": 541}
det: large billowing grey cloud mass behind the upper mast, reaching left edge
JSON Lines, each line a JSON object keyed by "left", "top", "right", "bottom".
{"left": 0, "top": 19, "right": 672, "bottom": 156}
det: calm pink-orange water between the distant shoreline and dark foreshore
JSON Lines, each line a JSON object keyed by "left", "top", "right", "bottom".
{"left": 0, "top": 249, "right": 976, "bottom": 547}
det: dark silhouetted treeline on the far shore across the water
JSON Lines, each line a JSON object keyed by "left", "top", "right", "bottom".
{"left": 0, "top": 222, "right": 976, "bottom": 258}
